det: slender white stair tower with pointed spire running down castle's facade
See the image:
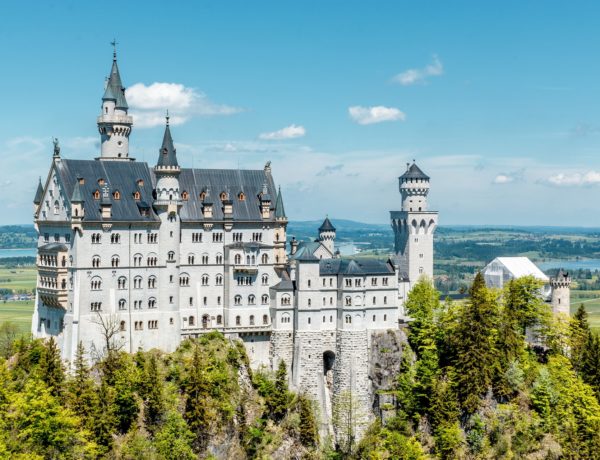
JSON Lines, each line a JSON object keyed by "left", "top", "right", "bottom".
{"left": 154, "top": 116, "right": 182, "bottom": 350}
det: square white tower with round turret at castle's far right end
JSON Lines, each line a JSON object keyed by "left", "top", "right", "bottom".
{"left": 390, "top": 162, "right": 438, "bottom": 286}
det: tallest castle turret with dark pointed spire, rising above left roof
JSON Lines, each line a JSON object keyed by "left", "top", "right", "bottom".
{"left": 98, "top": 45, "right": 133, "bottom": 160}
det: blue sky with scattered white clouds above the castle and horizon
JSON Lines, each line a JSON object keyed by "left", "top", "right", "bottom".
{"left": 0, "top": 0, "right": 600, "bottom": 226}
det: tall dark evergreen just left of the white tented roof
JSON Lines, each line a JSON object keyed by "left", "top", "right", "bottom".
{"left": 455, "top": 273, "right": 499, "bottom": 413}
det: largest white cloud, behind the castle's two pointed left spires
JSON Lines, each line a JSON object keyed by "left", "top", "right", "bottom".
{"left": 126, "top": 82, "right": 241, "bottom": 128}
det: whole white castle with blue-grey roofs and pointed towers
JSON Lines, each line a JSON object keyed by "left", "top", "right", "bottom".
{"left": 32, "top": 55, "right": 437, "bottom": 434}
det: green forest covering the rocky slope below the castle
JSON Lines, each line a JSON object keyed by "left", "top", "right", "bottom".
{"left": 0, "top": 275, "right": 600, "bottom": 460}
